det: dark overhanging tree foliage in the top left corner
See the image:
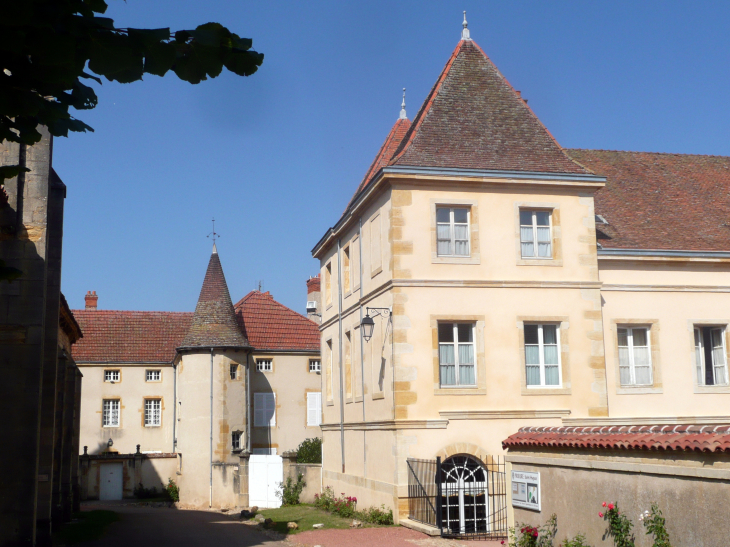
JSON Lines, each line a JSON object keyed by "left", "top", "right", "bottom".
{"left": 0, "top": 0, "right": 264, "bottom": 182}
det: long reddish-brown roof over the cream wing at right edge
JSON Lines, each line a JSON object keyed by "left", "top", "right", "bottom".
{"left": 566, "top": 149, "right": 730, "bottom": 251}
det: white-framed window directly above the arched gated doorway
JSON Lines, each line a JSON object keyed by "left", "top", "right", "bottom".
{"left": 438, "top": 323, "right": 476, "bottom": 387}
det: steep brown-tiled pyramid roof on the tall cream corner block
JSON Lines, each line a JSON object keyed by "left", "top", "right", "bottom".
{"left": 390, "top": 40, "right": 590, "bottom": 174}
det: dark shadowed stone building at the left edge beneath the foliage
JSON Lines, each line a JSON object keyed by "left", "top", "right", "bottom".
{"left": 0, "top": 129, "right": 81, "bottom": 545}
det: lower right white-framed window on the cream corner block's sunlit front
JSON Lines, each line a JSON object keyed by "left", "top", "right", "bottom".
{"left": 525, "top": 324, "right": 560, "bottom": 387}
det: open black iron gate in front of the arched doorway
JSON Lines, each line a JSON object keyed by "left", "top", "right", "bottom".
{"left": 406, "top": 455, "right": 507, "bottom": 539}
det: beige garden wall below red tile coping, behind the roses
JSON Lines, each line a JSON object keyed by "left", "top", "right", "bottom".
{"left": 507, "top": 450, "right": 730, "bottom": 547}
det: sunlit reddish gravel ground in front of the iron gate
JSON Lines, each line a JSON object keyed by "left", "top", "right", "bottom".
{"left": 287, "top": 527, "right": 501, "bottom": 547}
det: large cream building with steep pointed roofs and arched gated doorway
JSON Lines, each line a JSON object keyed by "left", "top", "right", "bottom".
{"left": 312, "top": 15, "right": 730, "bottom": 545}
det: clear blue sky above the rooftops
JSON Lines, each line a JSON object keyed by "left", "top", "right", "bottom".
{"left": 53, "top": 0, "right": 730, "bottom": 312}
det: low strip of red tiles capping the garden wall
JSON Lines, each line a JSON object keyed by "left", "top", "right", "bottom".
{"left": 502, "top": 425, "right": 730, "bottom": 453}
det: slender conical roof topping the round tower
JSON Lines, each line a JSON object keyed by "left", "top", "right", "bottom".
{"left": 181, "top": 245, "right": 250, "bottom": 348}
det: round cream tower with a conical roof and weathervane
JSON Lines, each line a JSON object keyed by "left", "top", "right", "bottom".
{"left": 175, "top": 244, "right": 251, "bottom": 507}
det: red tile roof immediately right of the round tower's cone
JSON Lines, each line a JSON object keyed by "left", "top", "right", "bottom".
{"left": 234, "top": 291, "right": 320, "bottom": 353}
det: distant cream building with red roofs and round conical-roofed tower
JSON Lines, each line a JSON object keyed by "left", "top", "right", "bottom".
{"left": 74, "top": 246, "right": 321, "bottom": 507}
